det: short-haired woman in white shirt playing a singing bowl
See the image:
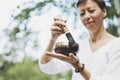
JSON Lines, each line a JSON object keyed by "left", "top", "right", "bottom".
{"left": 39, "top": 0, "right": 120, "bottom": 80}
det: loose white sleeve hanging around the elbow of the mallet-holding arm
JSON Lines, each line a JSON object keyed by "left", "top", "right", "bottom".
{"left": 39, "top": 58, "right": 71, "bottom": 74}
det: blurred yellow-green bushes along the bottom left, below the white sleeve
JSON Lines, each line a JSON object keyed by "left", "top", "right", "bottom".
{"left": 0, "top": 59, "right": 71, "bottom": 80}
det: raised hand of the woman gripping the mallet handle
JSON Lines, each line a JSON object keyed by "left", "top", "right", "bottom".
{"left": 51, "top": 16, "right": 66, "bottom": 40}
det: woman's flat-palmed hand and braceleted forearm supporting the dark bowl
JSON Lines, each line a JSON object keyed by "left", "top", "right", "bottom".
{"left": 46, "top": 52, "right": 91, "bottom": 80}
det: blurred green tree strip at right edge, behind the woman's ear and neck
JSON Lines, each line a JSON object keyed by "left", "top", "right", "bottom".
{"left": 107, "top": 0, "right": 120, "bottom": 36}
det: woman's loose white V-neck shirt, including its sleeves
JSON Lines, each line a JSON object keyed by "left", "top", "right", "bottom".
{"left": 39, "top": 38, "right": 120, "bottom": 80}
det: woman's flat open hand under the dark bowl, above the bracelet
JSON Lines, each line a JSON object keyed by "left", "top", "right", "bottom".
{"left": 46, "top": 52, "right": 81, "bottom": 69}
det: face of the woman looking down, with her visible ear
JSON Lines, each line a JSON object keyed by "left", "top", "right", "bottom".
{"left": 79, "top": 0, "right": 106, "bottom": 33}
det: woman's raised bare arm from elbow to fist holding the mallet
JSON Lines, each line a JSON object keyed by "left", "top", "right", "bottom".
{"left": 40, "top": 16, "right": 66, "bottom": 64}
